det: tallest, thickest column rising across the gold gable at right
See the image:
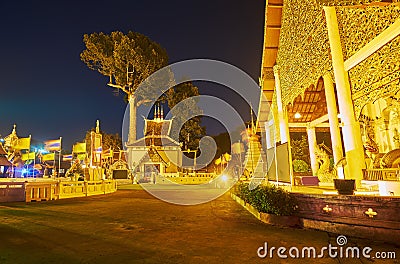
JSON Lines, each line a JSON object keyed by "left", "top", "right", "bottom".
{"left": 324, "top": 6, "right": 365, "bottom": 186}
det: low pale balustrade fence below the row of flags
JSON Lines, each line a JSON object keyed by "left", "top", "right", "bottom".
{"left": 0, "top": 180, "right": 117, "bottom": 202}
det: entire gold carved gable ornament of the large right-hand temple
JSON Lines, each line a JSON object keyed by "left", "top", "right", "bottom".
{"left": 277, "top": 0, "right": 400, "bottom": 116}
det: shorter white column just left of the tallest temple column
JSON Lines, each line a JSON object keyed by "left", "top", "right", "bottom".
{"left": 323, "top": 73, "right": 343, "bottom": 164}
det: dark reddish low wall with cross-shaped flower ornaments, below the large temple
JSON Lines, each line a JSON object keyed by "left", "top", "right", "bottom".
{"left": 293, "top": 193, "right": 400, "bottom": 245}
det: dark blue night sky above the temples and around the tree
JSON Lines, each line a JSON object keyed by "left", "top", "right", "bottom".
{"left": 0, "top": 0, "right": 265, "bottom": 152}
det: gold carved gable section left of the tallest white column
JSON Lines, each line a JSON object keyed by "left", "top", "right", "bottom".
{"left": 277, "top": 0, "right": 332, "bottom": 105}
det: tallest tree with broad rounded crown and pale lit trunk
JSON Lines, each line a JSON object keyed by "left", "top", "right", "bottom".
{"left": 81, "top": 31, "right": 168, "bottom": 142}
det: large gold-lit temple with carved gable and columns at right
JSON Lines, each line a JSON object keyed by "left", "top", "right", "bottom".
{"left": 258, "top": 0, "right": 400, "bottom": 187}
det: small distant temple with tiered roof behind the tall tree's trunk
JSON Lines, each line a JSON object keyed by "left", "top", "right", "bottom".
{"left": 126, "top": 105, "right": 182, "bottom": 180}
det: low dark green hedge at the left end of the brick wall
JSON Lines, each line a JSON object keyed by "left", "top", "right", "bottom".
{"left": 234, "top": 183, "right": 298, "bottom": 215}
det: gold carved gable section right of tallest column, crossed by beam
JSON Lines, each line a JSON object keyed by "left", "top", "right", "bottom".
{"left": 337, "top": 5, "right": 400, "bottom": 116}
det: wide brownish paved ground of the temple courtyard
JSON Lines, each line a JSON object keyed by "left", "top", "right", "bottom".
{"left": 0, "top": 185, "right": 400, "bottom": 264}
